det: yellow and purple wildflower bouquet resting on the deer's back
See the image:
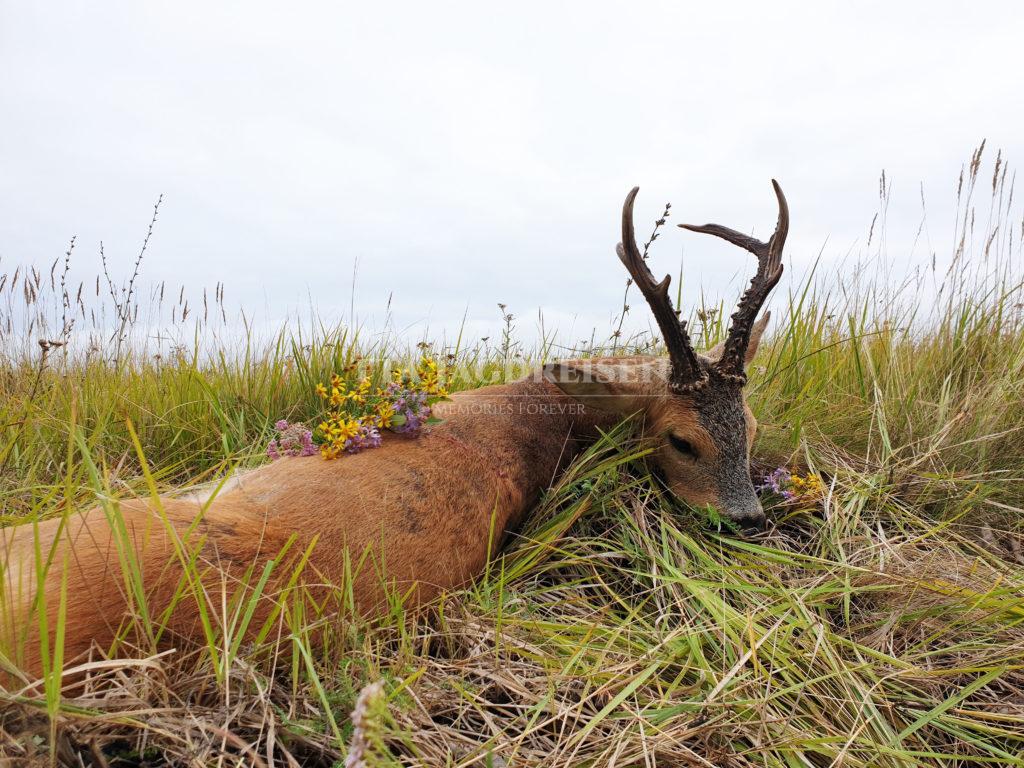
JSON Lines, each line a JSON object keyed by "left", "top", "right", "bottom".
{"left": 267, "top": 355, "right": 447, "bottom": 459}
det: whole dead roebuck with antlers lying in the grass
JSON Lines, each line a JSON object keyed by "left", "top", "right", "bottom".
{"left": 0, "top": 182, "right": 788, "bottom": 674}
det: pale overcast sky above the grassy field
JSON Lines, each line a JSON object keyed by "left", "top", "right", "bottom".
{"left": 0, "top": 0, "right": 1024, "bottom": 346}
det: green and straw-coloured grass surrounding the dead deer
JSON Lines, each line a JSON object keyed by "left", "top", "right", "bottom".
{"left": 0, "top": 143, "right": 1024, "bottom": 768}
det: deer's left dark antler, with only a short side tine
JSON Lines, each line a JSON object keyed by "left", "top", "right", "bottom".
{"left": 615, "top": 186, "right": 708, "bottom": 392}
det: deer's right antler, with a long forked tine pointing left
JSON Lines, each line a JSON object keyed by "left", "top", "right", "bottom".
{"left": 679, "top": 179, "right": 790, "bottom": 386}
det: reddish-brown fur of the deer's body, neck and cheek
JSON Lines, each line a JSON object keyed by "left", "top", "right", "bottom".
{"left": 0, "top": 324, "right": 764, "bottom": 674}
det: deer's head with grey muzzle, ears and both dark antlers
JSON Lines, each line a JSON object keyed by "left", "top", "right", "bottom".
{"left": 549, "top": 180, "right": 790, "bottom": 530}
